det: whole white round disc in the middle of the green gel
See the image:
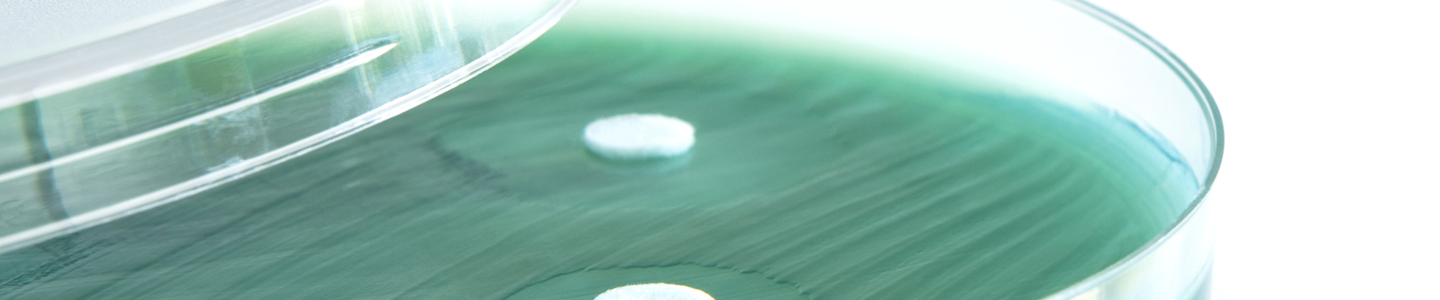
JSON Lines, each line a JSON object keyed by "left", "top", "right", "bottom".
{"left": 585, "top": 114, "right": 696, "bottom": 160}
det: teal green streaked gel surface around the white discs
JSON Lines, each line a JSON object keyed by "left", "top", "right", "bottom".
{"left": 0, "top": 18, "right": 1197, "bottom": 300}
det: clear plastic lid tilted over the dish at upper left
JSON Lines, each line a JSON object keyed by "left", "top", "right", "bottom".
{"left": 0, "top": 0, "right": 573, "bottom": 252}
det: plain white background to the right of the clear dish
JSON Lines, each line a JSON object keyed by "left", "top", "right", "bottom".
{"left": 1092, "top": 0, "right": 1440, "bottom": 300}
